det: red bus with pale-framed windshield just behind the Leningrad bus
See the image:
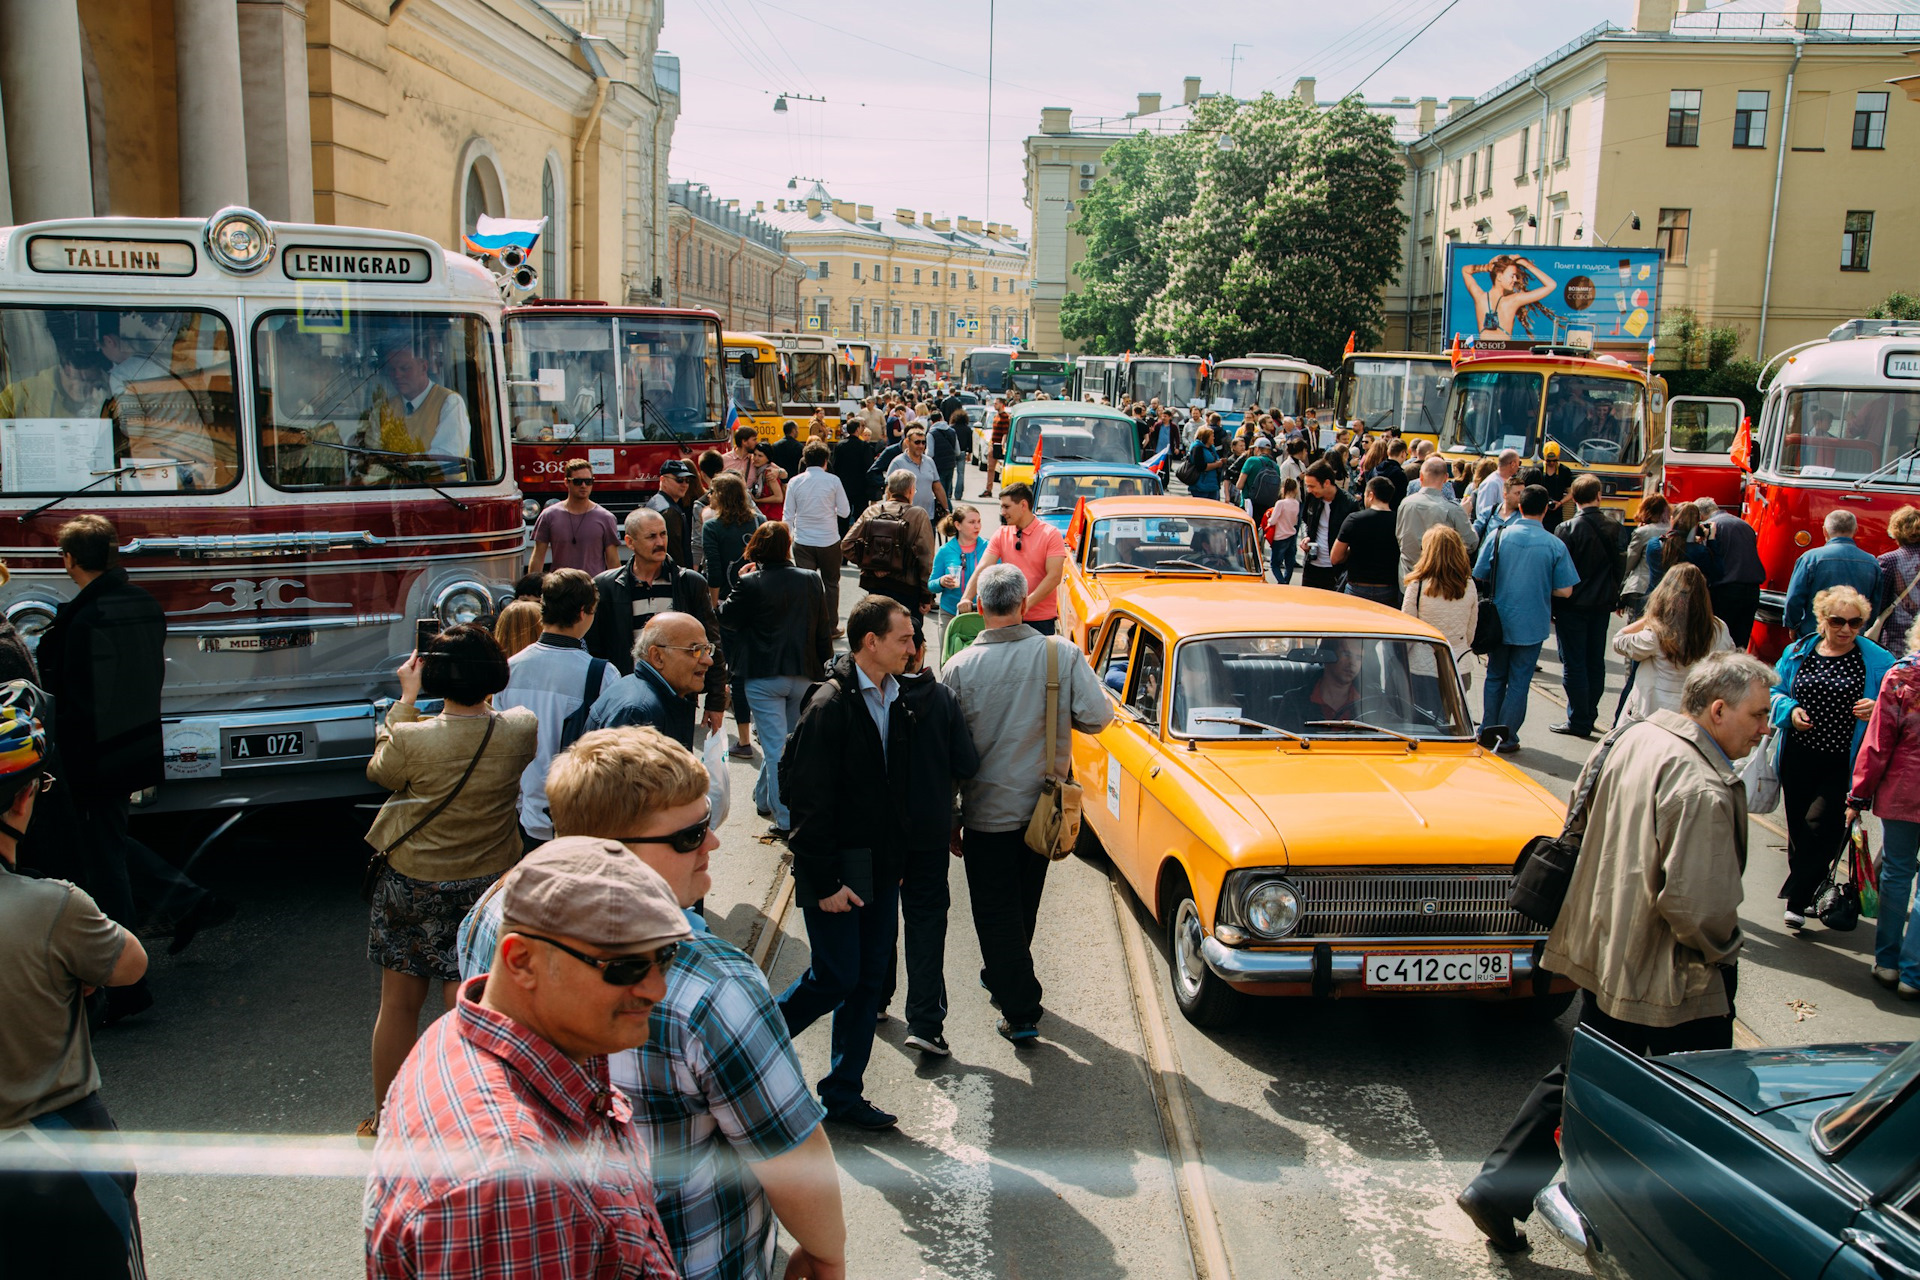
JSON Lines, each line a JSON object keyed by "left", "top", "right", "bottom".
{"left": 507, "top": 299, "right": 726, "bottom": 524}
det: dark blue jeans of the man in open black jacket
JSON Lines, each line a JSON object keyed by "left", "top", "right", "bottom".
{"left": 780, "top": 875, "right": 900, "bottom": 1113}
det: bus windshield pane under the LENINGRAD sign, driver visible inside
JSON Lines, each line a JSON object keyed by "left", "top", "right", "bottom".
{"left": 253, "top": 311, "right": 501, "bottom": 489}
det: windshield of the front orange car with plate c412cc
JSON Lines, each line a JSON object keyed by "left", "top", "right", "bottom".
{"left": 1171, "top": 635, "right": 1473, "bottom": 739}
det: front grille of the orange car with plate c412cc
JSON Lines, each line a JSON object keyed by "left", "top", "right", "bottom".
{"left": 1288, "top": 871, "right": 1540, "bottom": 938}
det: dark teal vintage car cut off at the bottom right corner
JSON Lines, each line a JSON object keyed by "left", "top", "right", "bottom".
{"left": 1534, "top": 1029, "right": 1920, "bottom": 1280}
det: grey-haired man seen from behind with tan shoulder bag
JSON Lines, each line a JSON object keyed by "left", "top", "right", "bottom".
{"left": 941, "top": 564, "right": 1114, "bottom": 1044}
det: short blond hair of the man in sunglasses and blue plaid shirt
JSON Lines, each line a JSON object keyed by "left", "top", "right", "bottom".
{"left": 547, "top": 725, "right": 707, "bottom": 841}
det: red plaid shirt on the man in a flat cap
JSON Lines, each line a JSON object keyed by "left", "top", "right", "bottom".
{"left": 363, "top": 981, "right": 676, "bottom": 1280}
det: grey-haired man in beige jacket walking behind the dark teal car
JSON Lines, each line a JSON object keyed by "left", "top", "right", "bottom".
{"left": 1459, "top": 652, "right": 1774, "bottom": 1251}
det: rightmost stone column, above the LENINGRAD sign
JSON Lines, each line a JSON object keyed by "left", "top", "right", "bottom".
{"left": 240, "top": 0, "right": 313, "bottom": 223}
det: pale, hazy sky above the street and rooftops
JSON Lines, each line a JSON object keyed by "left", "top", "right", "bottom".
{"left": 660, "top": 0, "right": 1634, "bottom": 228}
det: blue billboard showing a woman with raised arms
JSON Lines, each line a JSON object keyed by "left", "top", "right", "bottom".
{"left": 1444, "top": 244, "right": 1661, "bottom": 359}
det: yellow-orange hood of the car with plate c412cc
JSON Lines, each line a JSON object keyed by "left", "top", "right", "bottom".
{"left": 1175, "top": 741, "right": 1567, "bottom": 865}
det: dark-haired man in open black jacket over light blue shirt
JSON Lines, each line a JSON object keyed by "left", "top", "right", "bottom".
{"left": 780, "top": 595, "right": 918, "bottom": 1130}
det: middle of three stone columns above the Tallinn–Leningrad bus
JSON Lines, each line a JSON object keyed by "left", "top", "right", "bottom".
{"left": 173, "top": 0, "right": 248, "bottom": 217}
